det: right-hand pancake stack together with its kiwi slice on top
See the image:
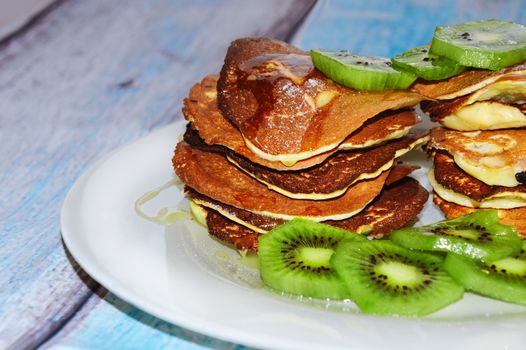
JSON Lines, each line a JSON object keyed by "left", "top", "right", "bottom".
{"left": 414, "top": 21, "right": 526, "bottom": 238}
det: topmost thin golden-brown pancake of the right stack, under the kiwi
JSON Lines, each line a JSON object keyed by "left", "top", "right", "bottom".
{"left": 412, "top": 63, "right": 526, "bottom": 100}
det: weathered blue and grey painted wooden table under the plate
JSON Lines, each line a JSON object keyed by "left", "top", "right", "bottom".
{"left": 0, "top": 0, "right": 526, "bottom": 349}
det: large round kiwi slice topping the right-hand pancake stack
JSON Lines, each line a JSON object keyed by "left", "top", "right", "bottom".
{"left": 429, "top": 19, "right": 526, "bottom": 70}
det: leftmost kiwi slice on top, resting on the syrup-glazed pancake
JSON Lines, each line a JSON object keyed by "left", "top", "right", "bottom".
{"left": 311, "top": 50, "right": 416, "bottom": 91}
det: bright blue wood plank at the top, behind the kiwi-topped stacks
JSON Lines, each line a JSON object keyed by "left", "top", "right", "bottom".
{"left": 294, "top": 0, "right": 526, "bottom": 57}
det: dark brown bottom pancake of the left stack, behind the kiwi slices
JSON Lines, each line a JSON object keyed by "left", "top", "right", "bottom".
{"left": 187, "top": 173, "right": 428, "bottom": 252}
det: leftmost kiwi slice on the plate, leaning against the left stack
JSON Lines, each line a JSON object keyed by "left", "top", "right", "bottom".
{"left": 258, "top": 218, "right": 366, "bottom": 299}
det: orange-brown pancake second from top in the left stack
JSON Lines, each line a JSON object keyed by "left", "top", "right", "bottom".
{"left": 183, "top": 75, "right": 420, "bottom": 170}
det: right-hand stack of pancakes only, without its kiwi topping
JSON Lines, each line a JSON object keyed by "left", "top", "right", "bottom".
{"left": 414, "top": 63, "right": 526, "bottom": 238}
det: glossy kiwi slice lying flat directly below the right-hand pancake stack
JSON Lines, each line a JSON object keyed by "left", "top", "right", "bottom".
{"left": 391, "top": 210, "right": 522, "bottom": 261}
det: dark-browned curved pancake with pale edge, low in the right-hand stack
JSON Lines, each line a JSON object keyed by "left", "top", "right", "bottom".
{"left": 429, "top": 152, "right": 526, "bottom": 209}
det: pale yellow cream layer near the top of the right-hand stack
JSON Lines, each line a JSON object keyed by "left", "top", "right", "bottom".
{"left": 440, "top": 101, "right": 526, "bottom": 131}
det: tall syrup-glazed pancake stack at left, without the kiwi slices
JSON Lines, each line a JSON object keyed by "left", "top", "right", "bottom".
{"left": 173, "top": 38, "right": 429, "bottom": 252}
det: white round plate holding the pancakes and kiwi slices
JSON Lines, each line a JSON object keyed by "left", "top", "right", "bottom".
{"left": 62, "top": 122, "right": 526, "bottom": 350}
